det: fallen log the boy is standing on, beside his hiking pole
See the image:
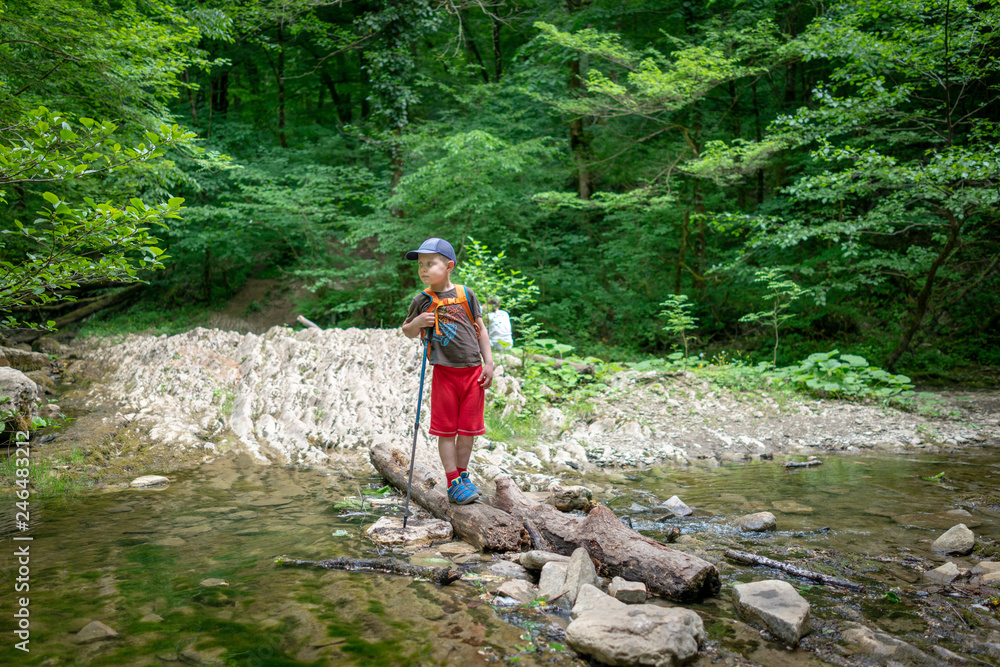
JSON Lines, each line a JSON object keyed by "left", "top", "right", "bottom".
{"left": 370, "top": 444, "right": 530, "bottom": 551}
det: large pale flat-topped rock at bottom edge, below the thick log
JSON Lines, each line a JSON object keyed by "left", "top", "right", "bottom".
{"left": 566, "top": 598, "right": 706, "bottom": 667}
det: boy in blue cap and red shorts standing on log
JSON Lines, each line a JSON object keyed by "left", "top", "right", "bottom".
{"left": 402, "top": 238, "right": 493, "bottom": 505}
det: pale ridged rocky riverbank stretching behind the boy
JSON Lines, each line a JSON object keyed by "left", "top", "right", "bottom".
{"left": 13, "top": 327, "right": 1000, "bottom": 488}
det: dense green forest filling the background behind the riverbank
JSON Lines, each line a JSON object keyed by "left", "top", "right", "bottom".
{"left": 0, "top": 0, "right": 1000, "bottom": 380}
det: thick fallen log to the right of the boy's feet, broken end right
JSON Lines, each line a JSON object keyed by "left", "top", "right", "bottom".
{"left": 488, "top": 477, "right": 722, "bottom": 601}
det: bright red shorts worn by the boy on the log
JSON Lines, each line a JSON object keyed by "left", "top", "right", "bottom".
{"left": 427, "top": 365, "right": 486, "bottom": 438}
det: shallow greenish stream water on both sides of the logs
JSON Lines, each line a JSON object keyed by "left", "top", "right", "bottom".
{"left": 0, "top": 448, "right": 1000, "bottom": 665}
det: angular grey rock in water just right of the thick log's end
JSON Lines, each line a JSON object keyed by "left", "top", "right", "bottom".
{"left": 733, "top": 579, "right": 809, "bottom": 646}
